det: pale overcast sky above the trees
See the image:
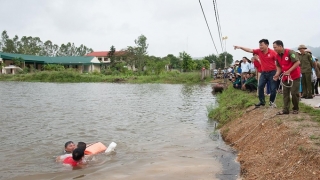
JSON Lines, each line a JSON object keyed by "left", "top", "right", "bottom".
{"left": 0, "top": 0, "right": 320, "bottom": 59}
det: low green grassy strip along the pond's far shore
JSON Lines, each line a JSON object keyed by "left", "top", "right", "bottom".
{"left": 0, "top": 70, "right": 211, "bottom": 84}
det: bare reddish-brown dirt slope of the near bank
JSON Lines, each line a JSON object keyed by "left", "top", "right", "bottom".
{"left": 221, "top": 107, "right": 320, "bottom": 180}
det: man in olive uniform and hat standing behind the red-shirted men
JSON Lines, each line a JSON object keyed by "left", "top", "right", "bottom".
{"left": 298, "top": 45, "right": 313, "bottom": 99}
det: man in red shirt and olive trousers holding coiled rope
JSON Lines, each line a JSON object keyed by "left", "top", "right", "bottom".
{"left": 273, "top": 40, "right": 300, "bottom": 115}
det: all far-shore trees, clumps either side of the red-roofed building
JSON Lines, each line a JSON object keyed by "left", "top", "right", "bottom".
{"left": 0, "top": 30, "right": 233, "bottom": 74}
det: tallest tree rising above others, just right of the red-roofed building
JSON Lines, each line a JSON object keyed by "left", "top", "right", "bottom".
{"left": 134, "top": 35, "right": 149, "bottom": 71}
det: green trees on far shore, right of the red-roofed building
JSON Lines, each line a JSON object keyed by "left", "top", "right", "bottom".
{"left": 108, "top": 35, "right": 233, "bottom": 74}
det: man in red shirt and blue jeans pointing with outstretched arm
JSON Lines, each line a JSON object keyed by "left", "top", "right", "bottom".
{"left": 234, "top": 39, "right": 277, "bottom": 107}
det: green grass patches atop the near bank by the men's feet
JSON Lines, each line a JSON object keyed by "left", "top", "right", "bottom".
{"left": 209, "top": 86, "right": 320, "bottom": 127}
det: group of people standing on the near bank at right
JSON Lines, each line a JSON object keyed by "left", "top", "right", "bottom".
{"left": 234, "top": 39, "right": 320, "bottom": 115}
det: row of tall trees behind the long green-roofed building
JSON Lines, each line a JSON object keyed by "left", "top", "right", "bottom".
{"left": 0, "top": 30, "right": 93, "bottom": 57}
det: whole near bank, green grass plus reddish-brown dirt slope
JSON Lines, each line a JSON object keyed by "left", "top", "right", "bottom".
{"left": 209, "top": 83, "right": 320, "bottom": 179}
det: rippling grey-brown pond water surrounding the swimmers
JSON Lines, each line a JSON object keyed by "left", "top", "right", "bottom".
{"left": 0, "top": 82, "right": 235, "bottom": 179}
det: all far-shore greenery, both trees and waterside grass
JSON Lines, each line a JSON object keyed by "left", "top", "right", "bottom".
{"left": 0, "top": 30, "right": 233, "bottom": 84}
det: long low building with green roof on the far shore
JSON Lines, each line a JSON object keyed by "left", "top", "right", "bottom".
{"left": 0, "top": 52, "right": 101, "bottom": 73}
